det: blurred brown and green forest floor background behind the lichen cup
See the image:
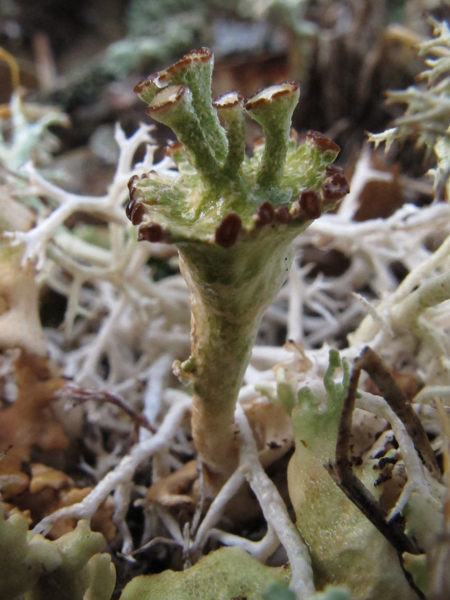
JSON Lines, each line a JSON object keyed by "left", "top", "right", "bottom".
{"left": 0, "top": 0, "right": 450, "bottom": 183}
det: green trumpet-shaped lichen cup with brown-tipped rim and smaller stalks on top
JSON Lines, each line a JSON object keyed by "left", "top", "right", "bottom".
{"left": 126, "top": 48, "right": 348, "bottom": 491}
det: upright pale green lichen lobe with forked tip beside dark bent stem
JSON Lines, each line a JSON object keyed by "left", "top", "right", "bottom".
{"left": 288, "top": 351, "right": 417, "bottom": 600}
